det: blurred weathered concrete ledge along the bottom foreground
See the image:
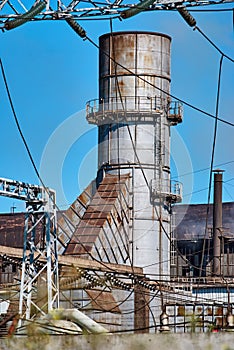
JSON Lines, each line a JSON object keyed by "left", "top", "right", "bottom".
{"left": 0, "top": 333, "right": 234, "bottom": 350}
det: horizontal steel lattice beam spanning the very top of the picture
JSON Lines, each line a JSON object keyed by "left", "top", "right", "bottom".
{"left": 0, "top": 0, "right": 234, "bottom": 30}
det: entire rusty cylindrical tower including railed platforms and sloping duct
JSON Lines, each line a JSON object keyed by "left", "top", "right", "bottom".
{"left": 65, "top": 32, "right": 182, "bottom": 280}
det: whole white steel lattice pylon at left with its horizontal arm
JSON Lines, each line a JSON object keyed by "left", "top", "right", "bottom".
{"left": 0, "top": 178, "right": 59, "bottom": 325}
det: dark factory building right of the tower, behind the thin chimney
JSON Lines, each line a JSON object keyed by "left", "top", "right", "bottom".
{"left": 171, "top": 202, "right": 234, "bottom": 278}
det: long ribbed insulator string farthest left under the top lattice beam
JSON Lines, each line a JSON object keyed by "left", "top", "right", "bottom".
{"left": 4, "top": 1, "right": 46, "bottom": 30}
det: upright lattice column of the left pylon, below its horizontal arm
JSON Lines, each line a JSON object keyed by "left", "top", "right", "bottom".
{"left": 19, "top": 208, "right": 59, "bottom": 325}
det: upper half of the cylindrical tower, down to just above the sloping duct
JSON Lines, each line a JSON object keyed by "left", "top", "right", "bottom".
{"left": 98, "top": 32, "right": 171, "bottom": 176}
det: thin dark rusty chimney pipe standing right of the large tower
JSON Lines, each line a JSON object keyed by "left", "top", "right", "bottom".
{"left": 213, "top": 170, "right": 223, "bottom": 276}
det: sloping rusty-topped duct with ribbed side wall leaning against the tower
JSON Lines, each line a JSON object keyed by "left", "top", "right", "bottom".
{"left": 65, "top": 175, "right": 129, "bottom": 263}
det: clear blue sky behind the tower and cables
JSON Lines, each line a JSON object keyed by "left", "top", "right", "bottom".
{"left": 0, "top": 4, "right": 234, "bottom": 212}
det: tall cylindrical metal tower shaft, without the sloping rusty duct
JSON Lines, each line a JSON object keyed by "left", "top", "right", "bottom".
{"left": 95, "top": 32, "right": 171, "bottom": 279}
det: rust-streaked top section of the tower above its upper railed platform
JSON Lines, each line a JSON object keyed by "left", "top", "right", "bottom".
{"left": 99, "top": 32, "right": 171, "bottom": 105}
